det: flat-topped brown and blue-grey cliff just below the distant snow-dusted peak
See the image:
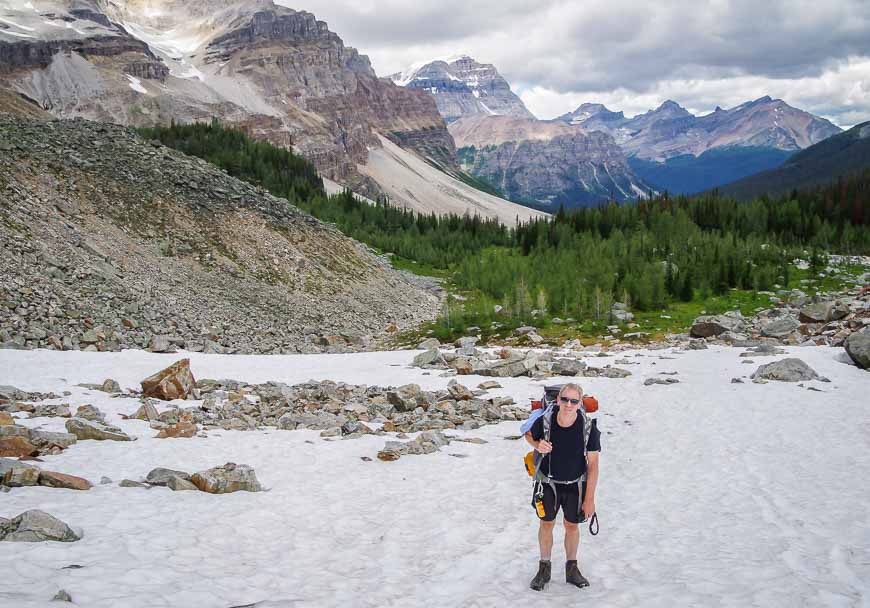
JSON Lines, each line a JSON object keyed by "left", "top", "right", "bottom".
{"left": 450, "top": 116, "right": 650, "bottom": 209}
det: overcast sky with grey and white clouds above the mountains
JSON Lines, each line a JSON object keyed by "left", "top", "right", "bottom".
{"left": 279, "top": 0, "right": 870, "bottom": 127}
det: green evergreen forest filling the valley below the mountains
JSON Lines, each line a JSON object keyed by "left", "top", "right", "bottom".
{"left": 140, "top": 122, "right": 870, "bottom": 334}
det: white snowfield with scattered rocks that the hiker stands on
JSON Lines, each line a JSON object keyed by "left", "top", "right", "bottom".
{"left": 0, "top": 347, "right": 870, "bottom": 608}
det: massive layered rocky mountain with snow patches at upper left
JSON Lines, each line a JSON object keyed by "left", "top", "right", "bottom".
{"left": 0, "top": 0, "right": 454, "bottom": 189}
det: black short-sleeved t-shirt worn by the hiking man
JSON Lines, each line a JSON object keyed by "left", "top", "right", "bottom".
{"left": 532, "top": 407, "right": 601, "bottom": 481}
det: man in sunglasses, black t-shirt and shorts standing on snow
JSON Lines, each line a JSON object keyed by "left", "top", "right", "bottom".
{"left": 525, "top": 384, "right": 601, "bottom": 591}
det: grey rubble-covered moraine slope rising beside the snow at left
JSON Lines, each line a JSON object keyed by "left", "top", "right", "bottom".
{"left": 0, "top": 114, "right": 440, "bottom": 352}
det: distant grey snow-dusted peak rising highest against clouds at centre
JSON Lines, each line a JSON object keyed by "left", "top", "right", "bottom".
{"left": 390, "top": 55, "right": 534, "bottom": 123}
